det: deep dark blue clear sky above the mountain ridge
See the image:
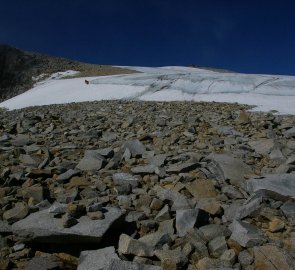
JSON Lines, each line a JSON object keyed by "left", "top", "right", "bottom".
{"left": 0, "top": 0, "right": 295, "bottom": 75}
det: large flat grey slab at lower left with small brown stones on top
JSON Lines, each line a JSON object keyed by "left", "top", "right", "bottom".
{"left": 12, "top": 207, "right": 124, "bottom": 243}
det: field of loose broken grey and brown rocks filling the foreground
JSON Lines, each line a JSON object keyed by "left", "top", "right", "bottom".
{"left": 0, "top": 101, "right": 295, "bottom": 270}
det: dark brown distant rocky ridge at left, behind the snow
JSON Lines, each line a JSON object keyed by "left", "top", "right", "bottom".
{"left": 0, "top": 45, "right": 134, "bottom": 102}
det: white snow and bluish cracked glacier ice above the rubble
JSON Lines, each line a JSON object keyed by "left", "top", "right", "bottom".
{"left": 0, "top": 67, "right": 295, "bottom": 114}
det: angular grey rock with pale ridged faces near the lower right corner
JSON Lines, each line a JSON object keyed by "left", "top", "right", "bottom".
{"left": 229, "top": 220, "right": 266, "bottom": 248}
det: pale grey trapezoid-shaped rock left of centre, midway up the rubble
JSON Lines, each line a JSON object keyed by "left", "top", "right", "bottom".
{"left": 76, "top": 150, "right": 106, "bottom": 171}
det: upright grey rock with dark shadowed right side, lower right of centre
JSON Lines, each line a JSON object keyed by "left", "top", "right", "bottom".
{"left": 175, "top": 209, "right": 200, "bottom": 237}
